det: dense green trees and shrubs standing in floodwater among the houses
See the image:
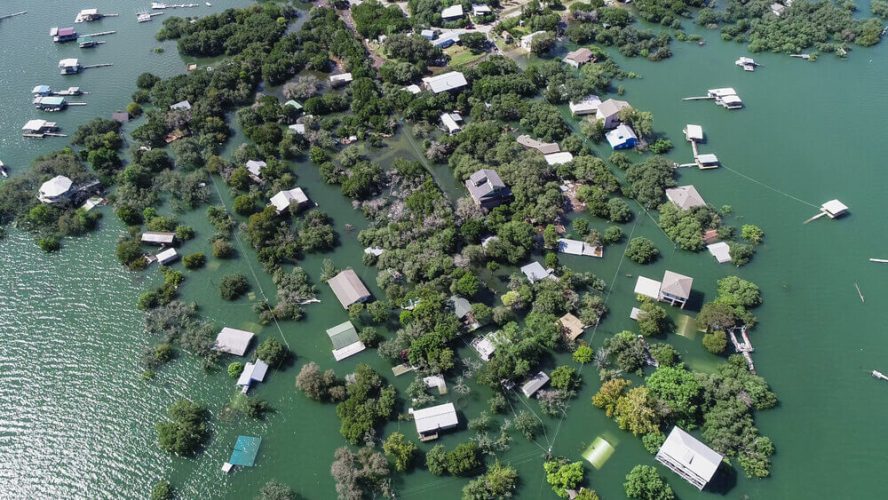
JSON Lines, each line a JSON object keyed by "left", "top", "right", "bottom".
{"left": 0, "top": 0, "right": 888, "bottom": 499}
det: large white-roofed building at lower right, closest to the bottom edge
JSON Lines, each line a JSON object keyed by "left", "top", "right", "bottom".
{"left": 657, "top": 426, "right": 724, "bottom": 490}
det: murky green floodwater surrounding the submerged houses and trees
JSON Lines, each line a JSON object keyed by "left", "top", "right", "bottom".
{"left": 0, "top": 0, "right": 888, "bottom": 499}
